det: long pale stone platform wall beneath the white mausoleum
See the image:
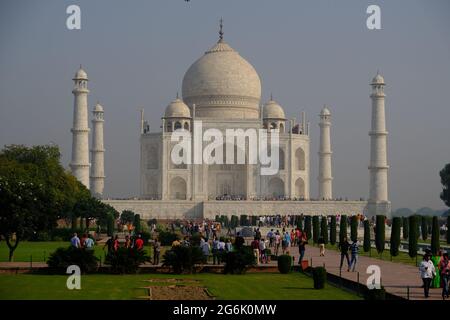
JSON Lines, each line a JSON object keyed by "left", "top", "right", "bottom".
{"left": 103, "top": 200, "right": 367, "bottom": 219}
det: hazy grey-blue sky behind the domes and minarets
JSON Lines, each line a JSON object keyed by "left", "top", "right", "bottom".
{"left": 0, "top": 0, "right": 450, "bottom": 208}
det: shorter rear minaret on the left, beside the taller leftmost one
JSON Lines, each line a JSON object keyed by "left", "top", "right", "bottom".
{"left": 91, "top": 103, "right": 105, "bottom": 198}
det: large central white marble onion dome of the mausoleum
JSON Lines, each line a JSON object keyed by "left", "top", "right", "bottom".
{"left": 182, "top": 39, "right": 261, "bottom": 119}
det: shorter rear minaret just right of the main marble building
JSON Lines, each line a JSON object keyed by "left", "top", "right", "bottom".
{"left": 317, "top": 106, "right": 333, "bottom": 200}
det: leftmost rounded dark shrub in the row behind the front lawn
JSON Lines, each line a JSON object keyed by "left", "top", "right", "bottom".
{"left": 47, "top": 246, "right": 98, "bottom": 273}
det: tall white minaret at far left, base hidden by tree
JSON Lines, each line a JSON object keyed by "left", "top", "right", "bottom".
{"left": 70, "top": 66, "right": 89, "bottom": 189}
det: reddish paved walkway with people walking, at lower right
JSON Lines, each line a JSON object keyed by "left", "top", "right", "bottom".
{"left": 290, "top": 245, "right": 442, "bottom": 300}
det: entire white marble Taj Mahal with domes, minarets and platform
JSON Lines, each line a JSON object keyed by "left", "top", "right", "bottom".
{"left": 70, "top": 23, "right": 390, "bottom": 219}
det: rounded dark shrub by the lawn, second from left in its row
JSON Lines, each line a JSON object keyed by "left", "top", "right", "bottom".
{"left": 105, "top": 247, "right": 150, "bottom": 274}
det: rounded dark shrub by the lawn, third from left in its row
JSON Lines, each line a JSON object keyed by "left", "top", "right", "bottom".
{"left": 163, "top": 246, "right": 204, "bottom": 274}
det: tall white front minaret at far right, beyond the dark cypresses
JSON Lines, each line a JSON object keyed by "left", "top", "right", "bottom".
{"left": 368, "top": 73, "right": 390, "bottom": 216}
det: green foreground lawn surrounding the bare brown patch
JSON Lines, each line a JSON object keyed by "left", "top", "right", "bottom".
{"left": 0, "top": 273, "right": 359, "bottom": 300}
